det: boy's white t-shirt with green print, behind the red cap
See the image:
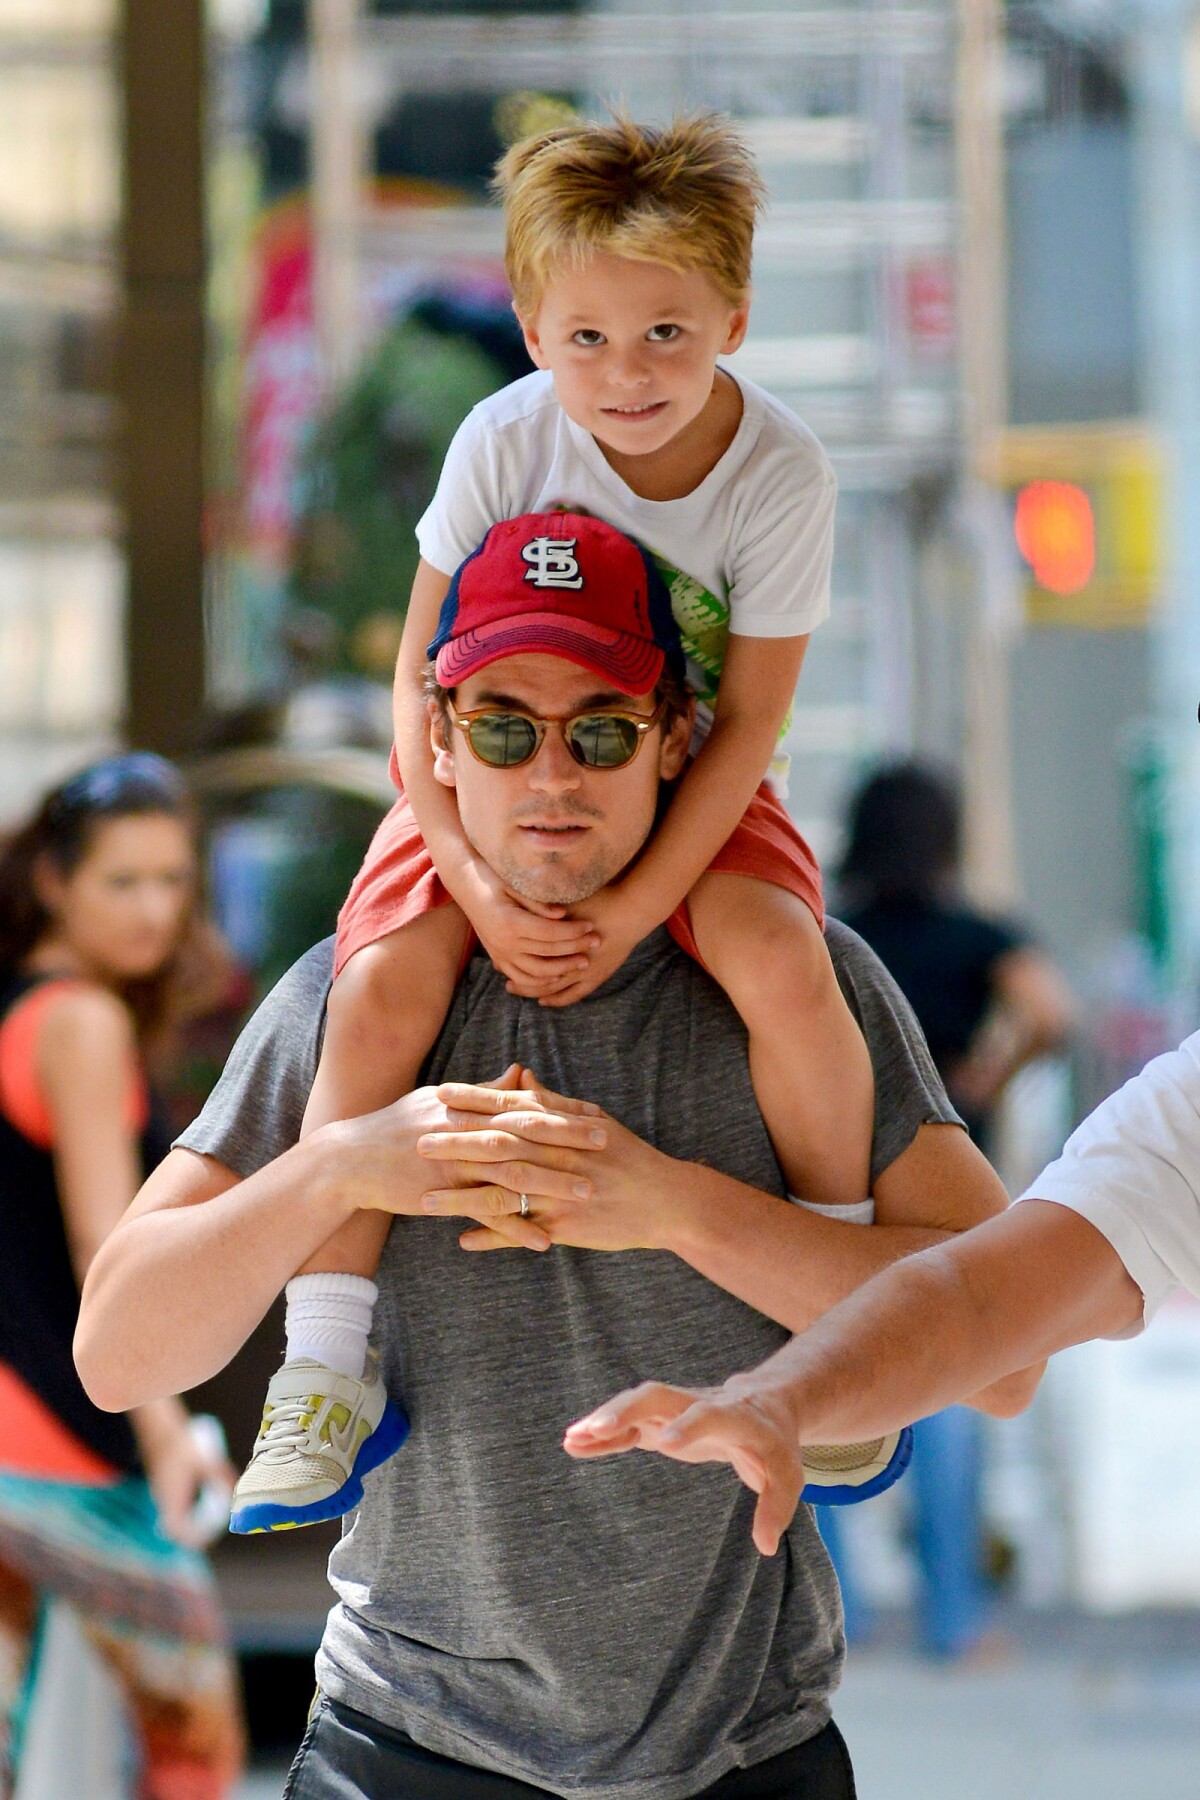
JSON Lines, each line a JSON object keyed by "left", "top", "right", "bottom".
{"left": 417, "top": 369, "right": 837, "bottom": 734}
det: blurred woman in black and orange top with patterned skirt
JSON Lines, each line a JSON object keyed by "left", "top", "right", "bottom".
{"left": 0, "top": 754, "right": 243, "bottom": 1800}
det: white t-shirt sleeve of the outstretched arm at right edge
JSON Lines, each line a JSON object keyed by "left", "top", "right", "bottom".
{"left": 1020, "top": 1031, "right": 1200, "bottom": 1323}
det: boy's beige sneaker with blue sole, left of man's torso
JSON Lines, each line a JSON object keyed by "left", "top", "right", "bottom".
{"left": 228, "top": 1350, "right": 408, "bottom": 1534}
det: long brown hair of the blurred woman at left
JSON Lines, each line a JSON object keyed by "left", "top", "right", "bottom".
{"left": 0, "top": 751, "right": 230, "bottom": 1062}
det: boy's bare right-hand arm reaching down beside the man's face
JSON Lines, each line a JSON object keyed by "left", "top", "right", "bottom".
{"left": 547, "top": 635, "right": 808, "bottom": 1006}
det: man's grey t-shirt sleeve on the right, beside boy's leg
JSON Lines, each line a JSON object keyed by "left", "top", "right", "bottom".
{"left": 826, "top": 918, "right": 966, "bottom": 1183}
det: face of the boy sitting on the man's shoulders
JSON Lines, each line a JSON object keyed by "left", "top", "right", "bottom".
{"left": 522, "top": 254, "right": 750, "bottom": 455}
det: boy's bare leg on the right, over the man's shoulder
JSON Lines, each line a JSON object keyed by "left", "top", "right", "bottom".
{"left": 689, "top": 873, "right": 874, "bottom": 1206}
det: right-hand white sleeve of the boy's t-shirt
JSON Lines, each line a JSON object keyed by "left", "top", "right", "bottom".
{"left": 729, "top": 455, "right": 837, "bottom": 637}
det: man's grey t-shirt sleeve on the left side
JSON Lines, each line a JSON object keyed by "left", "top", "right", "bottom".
{"left": 175, "top": 938, "right": 333, "bottom": 1179}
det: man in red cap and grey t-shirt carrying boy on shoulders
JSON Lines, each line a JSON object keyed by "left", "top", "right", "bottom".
{"left": 77, "top": 514, "right": 1029, "bottom": 1800}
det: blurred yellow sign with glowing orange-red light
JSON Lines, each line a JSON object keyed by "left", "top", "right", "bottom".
{"left": 986, "top": 423, "right": 1162, "bottom": 628}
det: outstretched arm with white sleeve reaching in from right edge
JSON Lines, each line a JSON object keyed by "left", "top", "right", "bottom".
{"left": 567, "top": 1033, "right": 1200, "bottom": 1555}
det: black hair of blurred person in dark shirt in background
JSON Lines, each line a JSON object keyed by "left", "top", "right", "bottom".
{"left": 838, "top": 763, "right": 963, "bottom": 905}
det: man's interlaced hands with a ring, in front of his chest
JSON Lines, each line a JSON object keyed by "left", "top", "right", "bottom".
{"left": 417, "top": 1071, "right": 687, "bottom": 1251}
